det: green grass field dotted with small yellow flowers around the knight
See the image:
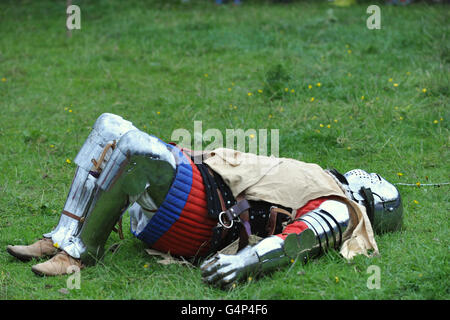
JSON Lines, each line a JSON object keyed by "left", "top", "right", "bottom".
{"left": 0, "top": 1, "right": 450, "bottom": 300}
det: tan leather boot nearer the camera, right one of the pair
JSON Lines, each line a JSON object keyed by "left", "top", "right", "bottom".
{"left": 31, "top": 251, "right": 84, "bottom": 276}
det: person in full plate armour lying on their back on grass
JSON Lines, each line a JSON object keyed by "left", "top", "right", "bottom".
{"left": 7, "top": 114, "right": 403, "bottom": 287}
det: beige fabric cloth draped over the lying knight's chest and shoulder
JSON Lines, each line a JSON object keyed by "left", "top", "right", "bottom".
{"left": 204, "top": 148, "right": 378, "bottom": 259}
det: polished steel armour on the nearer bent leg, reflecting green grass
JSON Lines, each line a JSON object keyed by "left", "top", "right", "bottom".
{"left": 64, "top": 130, "right": 176, "bottom": 265}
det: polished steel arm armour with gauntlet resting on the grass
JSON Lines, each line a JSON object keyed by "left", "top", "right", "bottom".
{"left": 200, "top": 200, "right": 349, "bottom": 287}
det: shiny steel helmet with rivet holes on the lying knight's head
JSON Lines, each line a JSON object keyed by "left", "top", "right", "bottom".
{"left": 344, "top": 169, "right": 403, "bottom": 234}
